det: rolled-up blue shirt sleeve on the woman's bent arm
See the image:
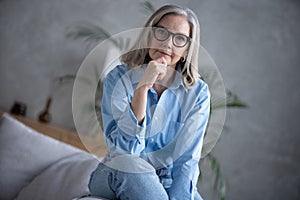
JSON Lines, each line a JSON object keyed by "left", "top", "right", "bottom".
{"left": 102, "top": 66, "right": 146, "bottom": 154}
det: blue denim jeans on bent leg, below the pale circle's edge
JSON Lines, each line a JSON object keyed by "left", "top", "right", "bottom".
{"left": 89, "top": 163, "right": 169, "bottom": 200}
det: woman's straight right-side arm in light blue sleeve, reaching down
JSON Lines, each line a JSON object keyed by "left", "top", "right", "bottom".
{"left": 167, "top": 84, "right": 210, "bottom": 200}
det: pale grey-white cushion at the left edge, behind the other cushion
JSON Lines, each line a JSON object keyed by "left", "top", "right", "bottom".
{"left": 0, "top": 113, "right": 83, "bottom": 200}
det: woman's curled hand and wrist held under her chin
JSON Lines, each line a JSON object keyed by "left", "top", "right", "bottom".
{"left": 137, "top": 57, "right": 167, "bottom": 90}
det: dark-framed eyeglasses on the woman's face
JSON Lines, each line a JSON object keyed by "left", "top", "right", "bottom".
{"left": 153, "top": 27, "right": 191, "bottom": 47}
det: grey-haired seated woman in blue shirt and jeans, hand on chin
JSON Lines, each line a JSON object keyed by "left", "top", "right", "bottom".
{"left": 89, "top": 5, "right": 210, "bottom": 200}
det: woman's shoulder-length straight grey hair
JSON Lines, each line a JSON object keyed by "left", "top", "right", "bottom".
{"left": 121, "top": 5, "right": 200, "bottom": 88}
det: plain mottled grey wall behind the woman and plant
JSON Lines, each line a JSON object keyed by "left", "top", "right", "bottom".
{"left": 0, "top": 0, "right": 300, "bottom": 200}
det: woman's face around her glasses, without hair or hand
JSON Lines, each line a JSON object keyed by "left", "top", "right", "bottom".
{"left": 149, "top": 15, "right": 190, "bottom": 68}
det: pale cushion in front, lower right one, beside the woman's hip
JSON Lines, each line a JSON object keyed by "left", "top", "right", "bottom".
{"left": 16, "top": 152, "right": 99, "bottom": 200}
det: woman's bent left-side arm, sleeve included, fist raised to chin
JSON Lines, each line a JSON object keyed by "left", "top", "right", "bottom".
{"left": 102, "top": 59, "right": 167, "bottom": 154}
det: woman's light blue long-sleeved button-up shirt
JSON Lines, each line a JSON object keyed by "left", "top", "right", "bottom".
{"left": 102, "top": 65, "right": 210, "bottom": 199}
